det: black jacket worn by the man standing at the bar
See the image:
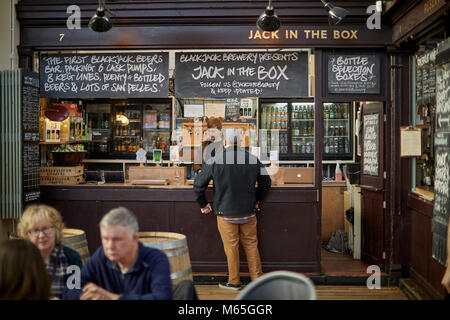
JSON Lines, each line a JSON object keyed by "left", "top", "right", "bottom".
{"left": 194, "top": 147, "right": 272, "bottom": 216}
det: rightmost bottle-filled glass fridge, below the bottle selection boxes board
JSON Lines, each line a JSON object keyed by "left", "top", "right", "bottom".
{"left": 323, "top": 103, "right": 351, "bottom": 155}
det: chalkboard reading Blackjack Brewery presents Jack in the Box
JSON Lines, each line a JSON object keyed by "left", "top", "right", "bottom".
{"left": 175, "top": 51, "right": 308, "bottom": 98}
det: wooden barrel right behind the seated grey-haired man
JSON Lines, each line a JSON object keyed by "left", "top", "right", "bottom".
{"left": 138, "top": 232, "right": 193, "bottom": 284}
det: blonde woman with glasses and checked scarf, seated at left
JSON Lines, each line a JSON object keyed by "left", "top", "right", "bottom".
{"left": 18, "top": 204, "right": 82, "bottom": 298}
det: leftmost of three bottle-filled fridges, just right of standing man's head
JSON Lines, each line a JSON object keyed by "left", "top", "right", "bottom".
{"left": 260, "top": 103, "right": 289, "bottom": 154}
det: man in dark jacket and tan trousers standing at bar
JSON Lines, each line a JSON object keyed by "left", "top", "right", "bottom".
{"left": 194, "top": 128, "right": 271, "bottom": 290}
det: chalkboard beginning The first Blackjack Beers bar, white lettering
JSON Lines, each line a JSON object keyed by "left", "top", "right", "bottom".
{"left": 40, "top": 52, "right": 169, "bottom": 98}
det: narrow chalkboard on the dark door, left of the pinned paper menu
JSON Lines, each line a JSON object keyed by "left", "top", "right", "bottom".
{"left": 363, "top": 114, "right": 380, "bottom": 176}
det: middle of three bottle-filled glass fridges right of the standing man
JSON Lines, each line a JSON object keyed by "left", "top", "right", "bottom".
{"left": 291, "top": 102, "right": 314, "bottom": 154}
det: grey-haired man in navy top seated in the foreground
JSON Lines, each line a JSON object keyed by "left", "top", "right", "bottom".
{"left": 63, "top": 207, "right": 172, "bottom": 300}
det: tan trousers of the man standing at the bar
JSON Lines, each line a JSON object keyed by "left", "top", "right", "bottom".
{"left": 217, "top": 217, "right": 263, "bottom": 285}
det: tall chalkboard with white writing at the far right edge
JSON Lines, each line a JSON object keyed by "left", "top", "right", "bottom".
{"left": 431, "top": 39, "right": 450, "bottom": 265}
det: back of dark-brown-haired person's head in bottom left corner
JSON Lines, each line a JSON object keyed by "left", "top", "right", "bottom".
{"left": 0, "top": 239, "right": 51, "bottom": 300}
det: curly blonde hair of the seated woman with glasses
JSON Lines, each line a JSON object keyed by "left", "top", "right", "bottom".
{"left": 17, "top": 204, "right": 64, "bottom": 243}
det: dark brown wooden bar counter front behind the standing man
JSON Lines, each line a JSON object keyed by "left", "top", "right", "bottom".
{"left": 41, "top": 183, "right": 321, "bottom": 273}
